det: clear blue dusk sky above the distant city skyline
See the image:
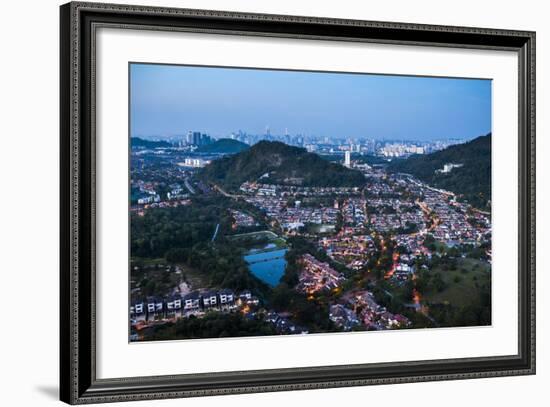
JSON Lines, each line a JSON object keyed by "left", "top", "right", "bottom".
{"left": 130, "top": 64, "right": 491, "bottom": 140}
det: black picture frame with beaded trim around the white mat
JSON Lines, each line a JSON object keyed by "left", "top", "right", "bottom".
{"left": 60, "top": 2, "right": 535, "bottom": 404}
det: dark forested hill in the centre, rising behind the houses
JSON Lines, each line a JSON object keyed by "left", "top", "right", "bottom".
{"left": 199, "top": 141, "right": 365, "bottom": 190}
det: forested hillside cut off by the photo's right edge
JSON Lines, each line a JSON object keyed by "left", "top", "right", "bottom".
{"left": 388, "top": 133, "right": 491, "bottom": 209}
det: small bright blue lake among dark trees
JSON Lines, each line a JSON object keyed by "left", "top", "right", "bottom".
{"left": 244, "top": 248, "right": 287, "bottom": 287}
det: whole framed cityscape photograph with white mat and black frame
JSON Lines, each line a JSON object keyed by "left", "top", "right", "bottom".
{"left": 60, "top": 2, "right": 535, "bottom": 404}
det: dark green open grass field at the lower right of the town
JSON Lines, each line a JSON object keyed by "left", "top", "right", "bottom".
{"left": 422, "top": 258, "right": 491, "bottom": 306}
